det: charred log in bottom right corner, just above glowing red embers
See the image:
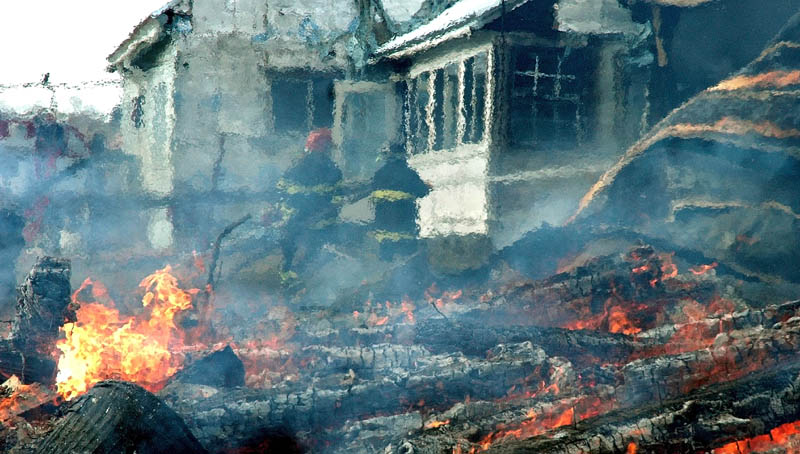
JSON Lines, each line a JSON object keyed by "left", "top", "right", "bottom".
{"left": 482, "top": 361, "right": 800, "bottom": 454}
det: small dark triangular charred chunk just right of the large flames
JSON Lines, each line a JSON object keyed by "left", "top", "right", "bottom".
{"left": 172, "top": 346, "right": 244, "bottom": 388}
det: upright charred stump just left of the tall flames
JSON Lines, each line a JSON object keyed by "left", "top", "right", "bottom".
{"left": 11, "top": 257, "right": 75, "bottom": 355}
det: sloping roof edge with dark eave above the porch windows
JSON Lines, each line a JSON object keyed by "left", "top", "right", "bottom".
{"left": 370, "top": 0, "right": 530, "bottom": 64}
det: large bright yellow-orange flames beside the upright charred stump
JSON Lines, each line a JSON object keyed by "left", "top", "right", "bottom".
{"left": 56, "top": 266, "right": 198, "bottom": 400}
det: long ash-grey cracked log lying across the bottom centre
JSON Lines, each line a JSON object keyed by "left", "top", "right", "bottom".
{"left": 159, "top": 343, "right": 552, "bottom": 451}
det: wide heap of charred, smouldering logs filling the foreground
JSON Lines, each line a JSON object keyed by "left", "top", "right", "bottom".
{"left": 0, "top": 235, "right": 800, "bottom": 454}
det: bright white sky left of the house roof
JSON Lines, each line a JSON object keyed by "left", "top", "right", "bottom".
{"left": 0, "top": 0, "right": 167, "bottom": 84}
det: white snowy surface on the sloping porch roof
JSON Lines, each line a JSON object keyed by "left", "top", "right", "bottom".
{"left": 375, "top": 0, "right": 527, "bottom": 55}
